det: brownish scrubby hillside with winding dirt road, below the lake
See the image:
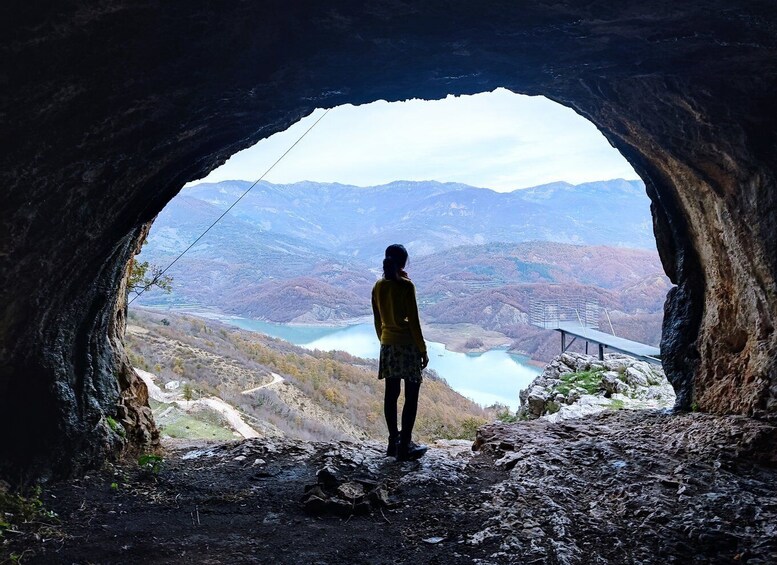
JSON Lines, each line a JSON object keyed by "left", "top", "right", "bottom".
{"left": 126, "top": 309, "right": 494, "bottom": 441}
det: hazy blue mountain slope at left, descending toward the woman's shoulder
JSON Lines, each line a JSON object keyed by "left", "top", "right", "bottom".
{"left": 139, "top": 195, "right": 374, "bottom": 311}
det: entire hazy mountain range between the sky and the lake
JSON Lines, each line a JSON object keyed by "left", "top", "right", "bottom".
{"left": 139, "top": 180, "right": 669, "bottom": 342}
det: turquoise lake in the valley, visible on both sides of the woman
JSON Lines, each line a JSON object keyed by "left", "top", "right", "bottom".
{"left": 203, "top": 316, "right": 540, "bottom": 410}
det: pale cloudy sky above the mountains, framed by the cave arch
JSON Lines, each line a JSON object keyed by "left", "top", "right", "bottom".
{"left": 190, "top": 89, "right": 639, "bottom": 192}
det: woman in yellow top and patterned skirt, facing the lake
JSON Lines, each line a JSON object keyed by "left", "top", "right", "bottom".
{"left": 372, "top": 243, "right": 429, "bottom": 461}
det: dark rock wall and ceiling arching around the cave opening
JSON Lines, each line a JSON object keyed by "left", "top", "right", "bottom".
{"left": 0, "top": 0, "right": 777, "bottom": 477}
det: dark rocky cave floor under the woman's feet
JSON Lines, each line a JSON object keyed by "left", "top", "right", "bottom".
{"left": 7, "top": 411, "right": 777, "bottom": 565}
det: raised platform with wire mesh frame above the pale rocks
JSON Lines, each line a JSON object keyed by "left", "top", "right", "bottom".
{"left": 530, "top": 300, "right": 661, "bottom": 365}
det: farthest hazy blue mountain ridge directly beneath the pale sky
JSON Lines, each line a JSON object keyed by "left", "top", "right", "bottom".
{"left": 162, "top": 179, "right": 655, "bottom": 262}
